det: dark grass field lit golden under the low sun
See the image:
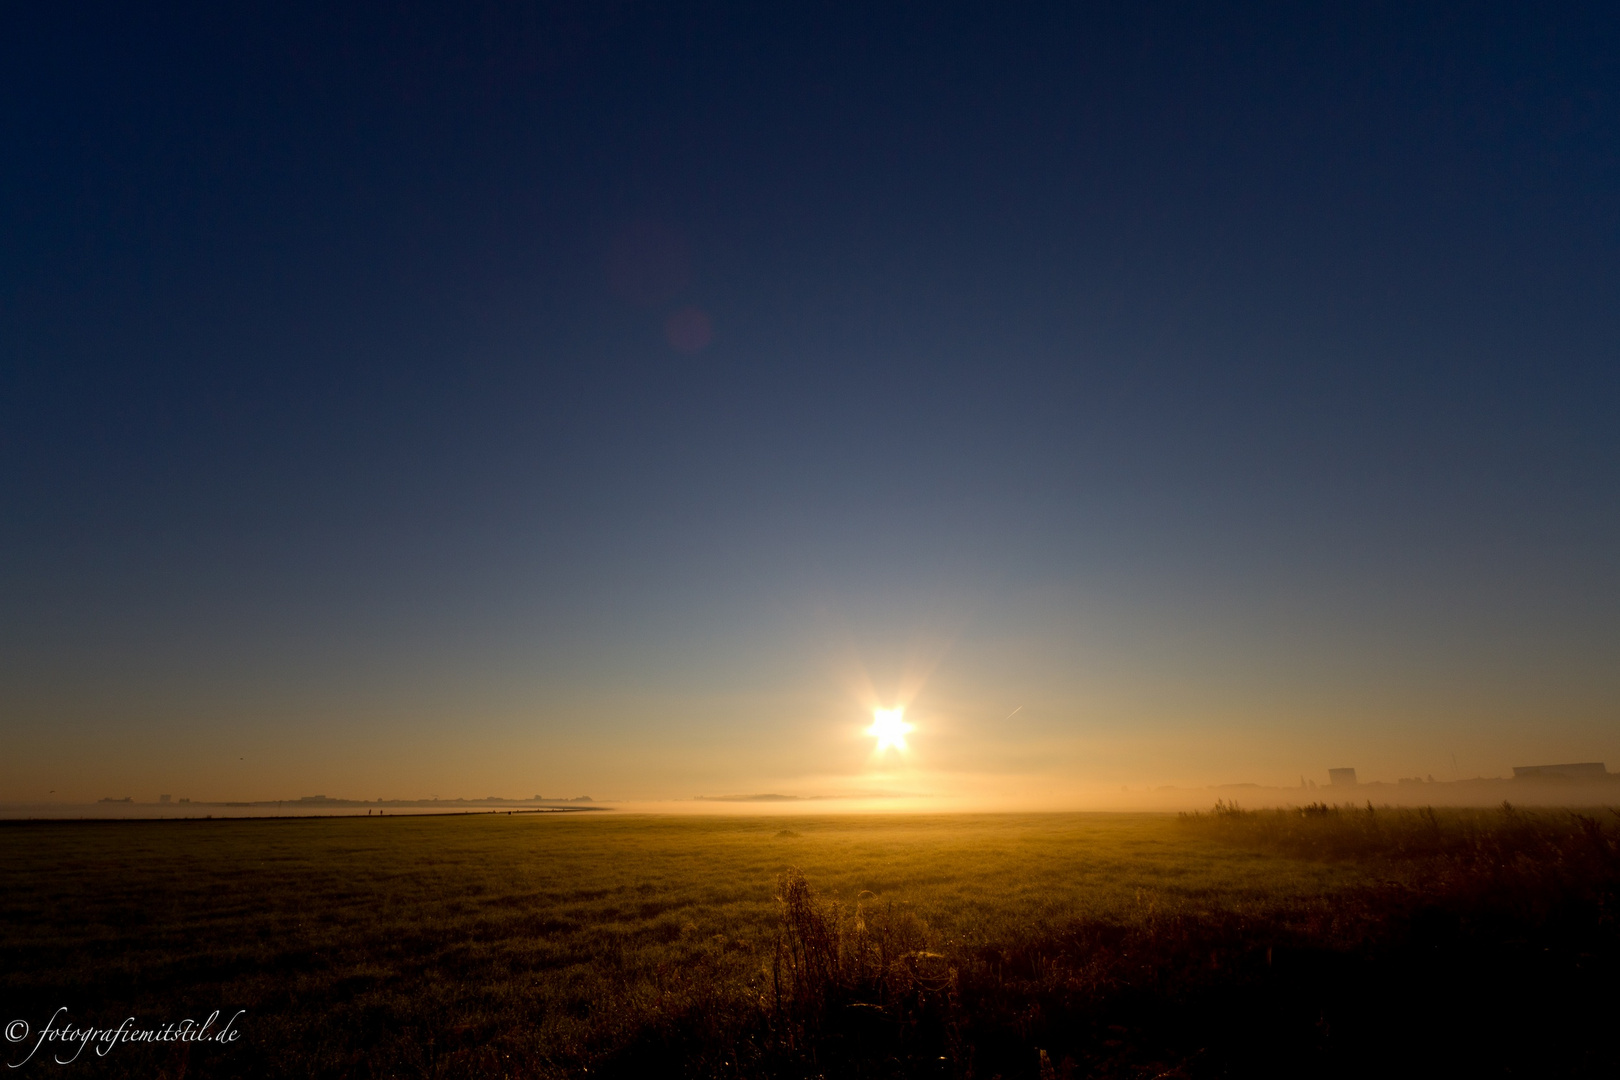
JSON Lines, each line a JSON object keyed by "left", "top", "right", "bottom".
{"left": 0, "top": 808, "right": 1620, "bottom": 1080}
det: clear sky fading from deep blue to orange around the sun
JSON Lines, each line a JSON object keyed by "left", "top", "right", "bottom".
{"left": 0, "top": 0, "right": 1620, "bottom": 806}
